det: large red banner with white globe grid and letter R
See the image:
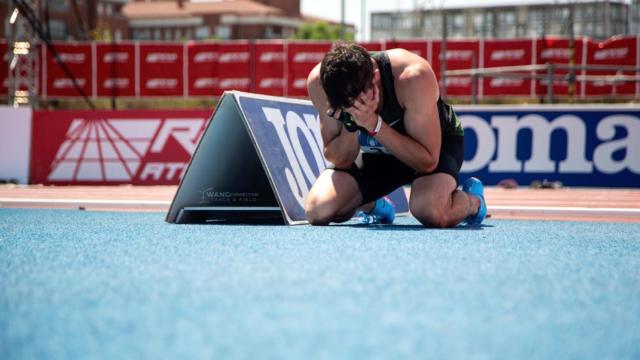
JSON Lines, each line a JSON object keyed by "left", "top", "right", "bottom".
{"left": 31, "top": 110, "right": 211, "bottom": 185}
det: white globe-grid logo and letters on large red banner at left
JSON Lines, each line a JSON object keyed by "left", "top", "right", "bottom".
{"left": 47, "top": 118, "right": 206, "bottom": 182}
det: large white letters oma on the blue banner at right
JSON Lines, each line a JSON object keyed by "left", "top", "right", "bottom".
{"left": 460, "top": 114, "right": 640, "bottom": 174}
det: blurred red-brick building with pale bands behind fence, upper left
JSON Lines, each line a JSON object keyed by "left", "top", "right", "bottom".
{"left": 0, "top": 0, "right": 354, "bottom": 41}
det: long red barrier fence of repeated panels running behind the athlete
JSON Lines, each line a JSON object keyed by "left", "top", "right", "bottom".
{"left": 0, "top": 36, "right": 640, "bottom": 99}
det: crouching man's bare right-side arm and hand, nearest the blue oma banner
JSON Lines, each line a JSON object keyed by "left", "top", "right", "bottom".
{"left": 348, "top": 51, "right": 442, "bottom": 172}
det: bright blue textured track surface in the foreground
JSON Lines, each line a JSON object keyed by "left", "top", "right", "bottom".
{"left": 0, "top": 209, "right": 640, "bottom": 359}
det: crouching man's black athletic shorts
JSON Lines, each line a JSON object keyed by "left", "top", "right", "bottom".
{"left": 334, "top": 135, "right": 464, "bottom": 204}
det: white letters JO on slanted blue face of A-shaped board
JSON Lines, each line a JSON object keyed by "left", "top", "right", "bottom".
{"left": 262, "top": 107, "right": 326, "bottom": 207}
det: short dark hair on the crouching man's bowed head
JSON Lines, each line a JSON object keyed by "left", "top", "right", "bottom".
{"left": 320, "top": 42, "right": 373, "bottom": 109}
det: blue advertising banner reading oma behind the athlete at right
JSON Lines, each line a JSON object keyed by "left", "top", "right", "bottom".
{"left": 455, "top": 105, "right": 640, "bottom": 187}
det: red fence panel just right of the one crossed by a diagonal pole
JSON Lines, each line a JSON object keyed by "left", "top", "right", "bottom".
{"left": 96, "top": 43, "right": 137, "bottom": 97}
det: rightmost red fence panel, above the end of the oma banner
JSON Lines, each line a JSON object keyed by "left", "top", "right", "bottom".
{"left": 586, "top": 37, "right": 638, "bottom": 96}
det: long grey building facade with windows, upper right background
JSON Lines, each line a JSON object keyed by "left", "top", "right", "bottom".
{"left": 371, "top": 0, "right": 638, "bottom": 40}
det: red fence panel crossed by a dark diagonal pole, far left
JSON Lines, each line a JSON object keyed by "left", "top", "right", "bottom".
{"left": 43, "top": 43, "right": 94, "bottom": 97}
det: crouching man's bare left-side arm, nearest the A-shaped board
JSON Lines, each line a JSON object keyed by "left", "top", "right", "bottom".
{"left": 307, "top": 65, "right": 360, "bottom": 168}
